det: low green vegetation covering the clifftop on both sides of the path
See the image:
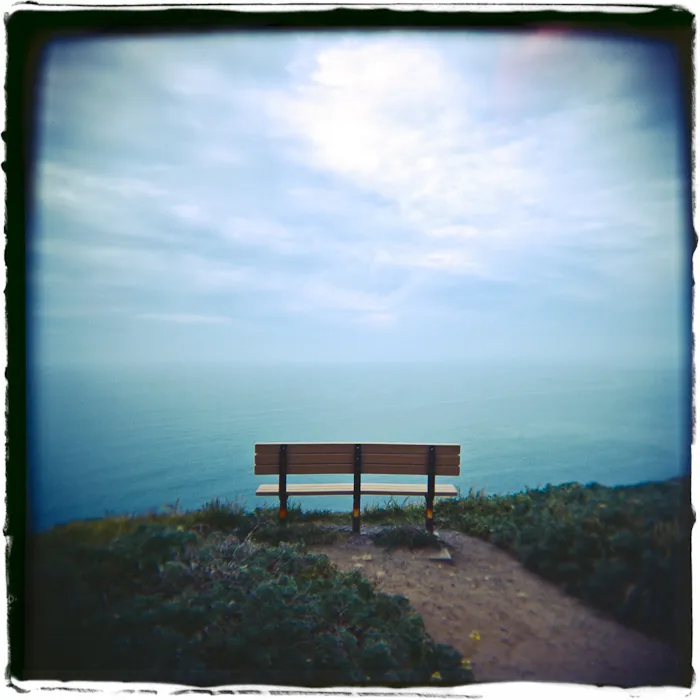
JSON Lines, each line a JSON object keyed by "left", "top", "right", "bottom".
{"left": 28, "top": 479, "right": 693, "bottom": 686}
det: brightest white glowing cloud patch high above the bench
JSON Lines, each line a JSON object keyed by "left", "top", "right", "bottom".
{"left": 270, "top": 40, "right": 537, "bottom": 229}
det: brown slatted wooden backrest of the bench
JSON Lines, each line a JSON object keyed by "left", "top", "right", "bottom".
{"left": 255, "top": 442, "right": 460, "bottom": 476}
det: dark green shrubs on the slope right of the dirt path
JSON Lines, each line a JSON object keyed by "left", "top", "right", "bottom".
{"left": 435, "top": 478, "right": 693, "bottom": 648}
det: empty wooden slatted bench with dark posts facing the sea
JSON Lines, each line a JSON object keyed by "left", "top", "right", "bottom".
{"left": 255, "top": 442, "right": 460, "bottom": 532}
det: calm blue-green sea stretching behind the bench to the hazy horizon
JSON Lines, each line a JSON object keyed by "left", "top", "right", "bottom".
{"left": 28, "top": 365, "right": 690, "bottom": 529}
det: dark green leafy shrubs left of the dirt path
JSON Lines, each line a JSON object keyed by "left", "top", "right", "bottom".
{"left": 28, "top": 523, "right": 472, "bottom": 686}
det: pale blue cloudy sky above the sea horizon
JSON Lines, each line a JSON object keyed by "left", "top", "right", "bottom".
{"left": 28, "top": 30, "right": 689, "bottom": 365}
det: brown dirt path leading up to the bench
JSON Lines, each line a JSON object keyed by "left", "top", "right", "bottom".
{"left": 311, "top": 531, "right": 683, "bottom": 687}
